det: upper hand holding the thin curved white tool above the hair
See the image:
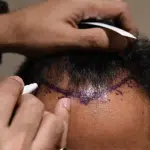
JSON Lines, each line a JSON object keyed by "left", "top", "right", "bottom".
{"left": 13, "top": 0, "right": 136, "bottom": 55}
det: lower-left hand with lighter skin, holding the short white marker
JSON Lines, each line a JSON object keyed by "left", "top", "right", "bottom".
{"left": 0, "top": 77, "right": 70, "bottom": 150}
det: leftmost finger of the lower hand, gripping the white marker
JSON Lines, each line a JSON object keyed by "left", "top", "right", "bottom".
{"left": 0, "top": 76, "right": 24, "bottom": 126}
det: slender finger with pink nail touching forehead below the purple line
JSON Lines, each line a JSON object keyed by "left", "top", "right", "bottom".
{"left": 55, "top": 98, "right": 70, "bottom": 148}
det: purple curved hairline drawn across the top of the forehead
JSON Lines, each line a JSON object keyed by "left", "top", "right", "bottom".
{"left": 43, "top": 77, "right": 133, "bottom": 105}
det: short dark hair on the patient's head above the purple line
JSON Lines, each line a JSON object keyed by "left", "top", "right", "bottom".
{"left": 17, "top": 38, "right": 150, "bottom": 96}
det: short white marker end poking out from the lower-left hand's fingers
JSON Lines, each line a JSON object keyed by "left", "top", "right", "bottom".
{"left": 22, "top": 83, "right": 38, "bottom": 95}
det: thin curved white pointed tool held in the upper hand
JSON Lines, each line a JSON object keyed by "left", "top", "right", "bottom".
{"left": 82, "top": 22, "right": 137, "bottom": 39}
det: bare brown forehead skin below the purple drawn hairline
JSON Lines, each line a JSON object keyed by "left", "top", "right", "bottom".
{"left": 37, "top": 73, "right": 150, "bottom": 150}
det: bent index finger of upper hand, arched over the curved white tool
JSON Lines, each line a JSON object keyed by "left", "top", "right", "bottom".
{"left": 79, "top": 0, "right": 137, "bottom": 33}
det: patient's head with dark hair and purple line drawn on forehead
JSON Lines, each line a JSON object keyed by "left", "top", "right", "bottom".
{"left": 18, "top": 37, "right": 150, "bottom": 150}
